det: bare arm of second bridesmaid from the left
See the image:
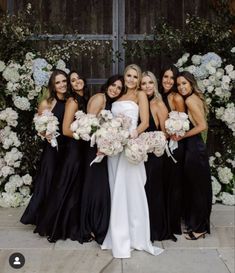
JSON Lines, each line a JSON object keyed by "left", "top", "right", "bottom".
{"left": 63, "top": 98, "right": 78, "bottom": 137}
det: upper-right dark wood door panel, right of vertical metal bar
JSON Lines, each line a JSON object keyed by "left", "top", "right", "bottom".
{"left": 125, "top": 0, "right": 213, "bottom": 34}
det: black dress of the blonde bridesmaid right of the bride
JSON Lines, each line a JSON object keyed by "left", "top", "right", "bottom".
{"left": 145, "top": 100, "right": 169, "bottom": 242}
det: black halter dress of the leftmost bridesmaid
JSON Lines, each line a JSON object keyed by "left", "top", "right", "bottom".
{"left": 20, "top": 98, "right": 65, "bottom": 225}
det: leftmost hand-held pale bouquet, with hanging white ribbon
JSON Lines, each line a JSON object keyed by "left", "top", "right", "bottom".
{"left": 33, "top": 109, "right": 60, "bottom": 147}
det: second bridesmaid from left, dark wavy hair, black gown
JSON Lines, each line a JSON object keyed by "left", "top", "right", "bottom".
{"left": 35, "top": 71, "right": 88, "bottom": 242}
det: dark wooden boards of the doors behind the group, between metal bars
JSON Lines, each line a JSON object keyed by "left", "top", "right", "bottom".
{"left": 7, "top": 0, "right": 217, "bottom": 83}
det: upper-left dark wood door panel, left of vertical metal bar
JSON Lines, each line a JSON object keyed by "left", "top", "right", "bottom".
{"left": 14, "top": 0, "right": 112, "bottom": 34}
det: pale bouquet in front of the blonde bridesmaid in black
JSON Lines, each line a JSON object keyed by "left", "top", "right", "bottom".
{"left": 139, "top": 131, "right": 167, "bottom": 157}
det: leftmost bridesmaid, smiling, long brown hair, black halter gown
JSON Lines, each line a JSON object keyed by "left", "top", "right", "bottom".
{"left": 20, "top": 69, "right": 68, "bottom": 225}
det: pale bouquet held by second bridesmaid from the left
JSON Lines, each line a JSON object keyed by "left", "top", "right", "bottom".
{"left": 70, "top": 110, "right": 99, "bottom": 141}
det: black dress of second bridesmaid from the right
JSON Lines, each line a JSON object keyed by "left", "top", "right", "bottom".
{"left": 162, "top": 93, "right": 185, "bottom": 236}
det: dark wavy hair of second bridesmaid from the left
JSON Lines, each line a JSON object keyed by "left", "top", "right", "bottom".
{"left": 68, "top": 70, "right": 90, "bottom": 112}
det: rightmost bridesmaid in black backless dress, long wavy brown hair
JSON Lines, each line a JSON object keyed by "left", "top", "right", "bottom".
{"left": 175, "top": 71, "right": 212, "bottom": 240}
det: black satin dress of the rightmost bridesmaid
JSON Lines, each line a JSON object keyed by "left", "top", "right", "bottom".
{"left": 184, "top": 95, "right": 212, "bottom": 233}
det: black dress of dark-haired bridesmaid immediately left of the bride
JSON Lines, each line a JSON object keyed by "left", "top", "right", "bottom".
{"left": 79, "top": 96, "right": 112, "bottom": 244}
